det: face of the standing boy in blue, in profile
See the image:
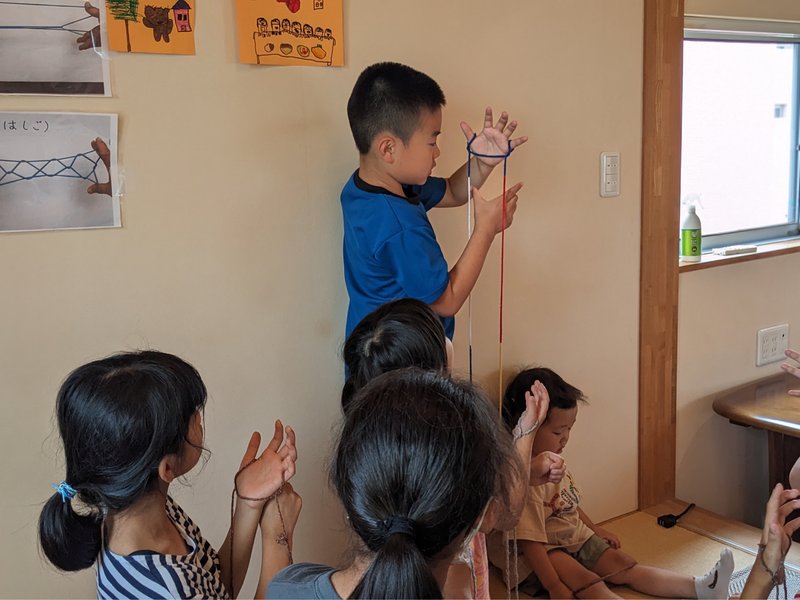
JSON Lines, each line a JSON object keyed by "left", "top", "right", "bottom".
{"left": 392, "top": 108, "right": 442, "bottom": 185}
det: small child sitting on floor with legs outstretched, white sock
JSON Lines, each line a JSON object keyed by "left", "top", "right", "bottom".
{"left": 489, "top": 368, "right": 733, "bottom": 598}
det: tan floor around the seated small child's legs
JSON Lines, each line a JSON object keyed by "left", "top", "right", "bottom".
{"left": 491, "top": 500, "right": 800, "bottom": 600}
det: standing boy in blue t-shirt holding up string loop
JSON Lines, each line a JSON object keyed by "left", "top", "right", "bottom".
{"left": 341, "top": 62, "right": 528, "bottom": 339}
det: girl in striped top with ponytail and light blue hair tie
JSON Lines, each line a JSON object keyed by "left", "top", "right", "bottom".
{"left": 39, "top": 351, "right": 300, "bottom": 598}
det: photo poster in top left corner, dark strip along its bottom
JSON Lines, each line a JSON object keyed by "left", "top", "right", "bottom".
{"left": 0, "top": 0, "right": 111, "bottom": 96}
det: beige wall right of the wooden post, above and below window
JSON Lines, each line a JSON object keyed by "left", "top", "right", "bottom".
{"left": 677, "top": 0, "right": 800, "bottom": 524}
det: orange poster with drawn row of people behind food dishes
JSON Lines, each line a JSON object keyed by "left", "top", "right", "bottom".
{"left": 236, "top": 0, "right": 344, "bottom": 67}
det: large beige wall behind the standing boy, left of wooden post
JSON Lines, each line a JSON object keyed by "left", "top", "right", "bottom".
{"left": 0, "top": 0, "right": 643, "bottom": 597}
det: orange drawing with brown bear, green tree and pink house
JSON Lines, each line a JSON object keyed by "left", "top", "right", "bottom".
{"left": 106, "top": 0, "right": 195, "bottom": 54}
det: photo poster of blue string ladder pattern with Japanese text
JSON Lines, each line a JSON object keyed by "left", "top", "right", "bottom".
{"left": 0, "top": 112, "right": 120, "bottom": 232}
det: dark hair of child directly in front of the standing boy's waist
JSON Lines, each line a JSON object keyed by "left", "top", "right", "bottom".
{"left": 342, "top": 298, "right": 447, "bottom": 411}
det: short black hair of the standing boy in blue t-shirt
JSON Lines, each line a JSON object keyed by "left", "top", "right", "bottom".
{"left": 347, "top": 62, "right": 445, "bottom": 154}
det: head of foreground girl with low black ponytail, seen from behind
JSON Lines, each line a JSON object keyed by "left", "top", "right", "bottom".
{"left": 330, "top": 368, "right": 521, "bottom": 598}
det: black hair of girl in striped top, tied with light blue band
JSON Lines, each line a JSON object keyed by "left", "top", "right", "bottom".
{"left": 39, "top": 351, "right": 206, "bottom": 571}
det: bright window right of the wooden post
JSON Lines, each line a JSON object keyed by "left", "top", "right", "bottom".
{"left": 681, "top": 16, "right": 800, "bottom": 250}
